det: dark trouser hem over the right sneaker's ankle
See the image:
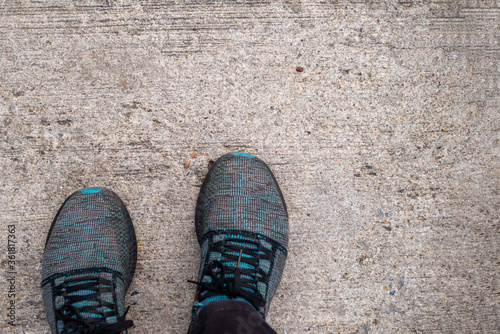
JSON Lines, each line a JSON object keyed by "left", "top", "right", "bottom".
{"left": 188, "top": 299, "right": 277, "bottom": 334}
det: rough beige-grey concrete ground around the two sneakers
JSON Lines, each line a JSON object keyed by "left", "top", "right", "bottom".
{"left": 0, "top": 0, "right": 500, "bottom": 334}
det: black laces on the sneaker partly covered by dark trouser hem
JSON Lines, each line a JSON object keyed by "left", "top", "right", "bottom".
{"left": 188, "top": 239, "right": 271, "bottom": 309}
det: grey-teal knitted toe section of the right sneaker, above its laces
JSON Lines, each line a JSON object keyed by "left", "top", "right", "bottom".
{"left": 196, "top": 153, "right": 288, "bottom": 248}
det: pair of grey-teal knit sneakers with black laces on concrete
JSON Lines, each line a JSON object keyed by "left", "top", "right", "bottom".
{"left": 42, "top": 153, "right": 288, "bottom": 334}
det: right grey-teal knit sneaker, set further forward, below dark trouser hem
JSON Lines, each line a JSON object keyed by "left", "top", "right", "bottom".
{"left": 191, "top": 153, "right": 288, "bottom": 326}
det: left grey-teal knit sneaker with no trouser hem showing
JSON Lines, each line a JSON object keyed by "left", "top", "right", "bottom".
{"left": 42, "top": 188, "right": 137, "bottom": 334}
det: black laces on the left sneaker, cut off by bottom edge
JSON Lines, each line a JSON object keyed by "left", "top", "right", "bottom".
{"left": 55, "top": 276, "right": 134, "bottom": 334}
